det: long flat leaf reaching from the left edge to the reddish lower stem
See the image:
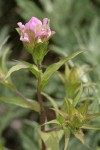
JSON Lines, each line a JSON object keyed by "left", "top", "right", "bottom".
{"left": 0, "top": 97, "right": 40, "bottom": 112}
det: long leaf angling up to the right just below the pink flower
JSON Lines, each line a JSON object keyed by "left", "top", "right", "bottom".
{"left": 40, "top": 51, "right": 83, "bottom": 89}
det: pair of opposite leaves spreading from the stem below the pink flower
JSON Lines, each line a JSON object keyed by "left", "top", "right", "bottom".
{"left": 5, "top": 51, "right": 83, "bottom": 90}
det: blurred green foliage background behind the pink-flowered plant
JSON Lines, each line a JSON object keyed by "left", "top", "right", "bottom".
{"left": 0, "top": 0, "right": 100, "bottom": 150}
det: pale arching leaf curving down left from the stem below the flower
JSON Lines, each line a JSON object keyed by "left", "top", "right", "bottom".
{"left": 5, "top": 62, "right": 40, "bottom": 79}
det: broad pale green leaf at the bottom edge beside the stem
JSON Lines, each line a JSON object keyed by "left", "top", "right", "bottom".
{"left": 40, "top": 131, "right": 59, "bottom": 150}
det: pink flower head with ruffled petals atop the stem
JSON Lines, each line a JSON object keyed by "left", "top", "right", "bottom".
{"left": 18, "top": 17, "right": 55, "bottom": 45}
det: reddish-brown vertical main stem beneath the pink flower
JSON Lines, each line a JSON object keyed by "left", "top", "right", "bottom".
{"left": 37, "top": 64, "right": 46, "bottom": 150}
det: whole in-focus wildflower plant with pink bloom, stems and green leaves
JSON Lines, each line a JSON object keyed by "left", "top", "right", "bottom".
{"left": 0, "top": 17, "right": 100, "bottom": 150}
